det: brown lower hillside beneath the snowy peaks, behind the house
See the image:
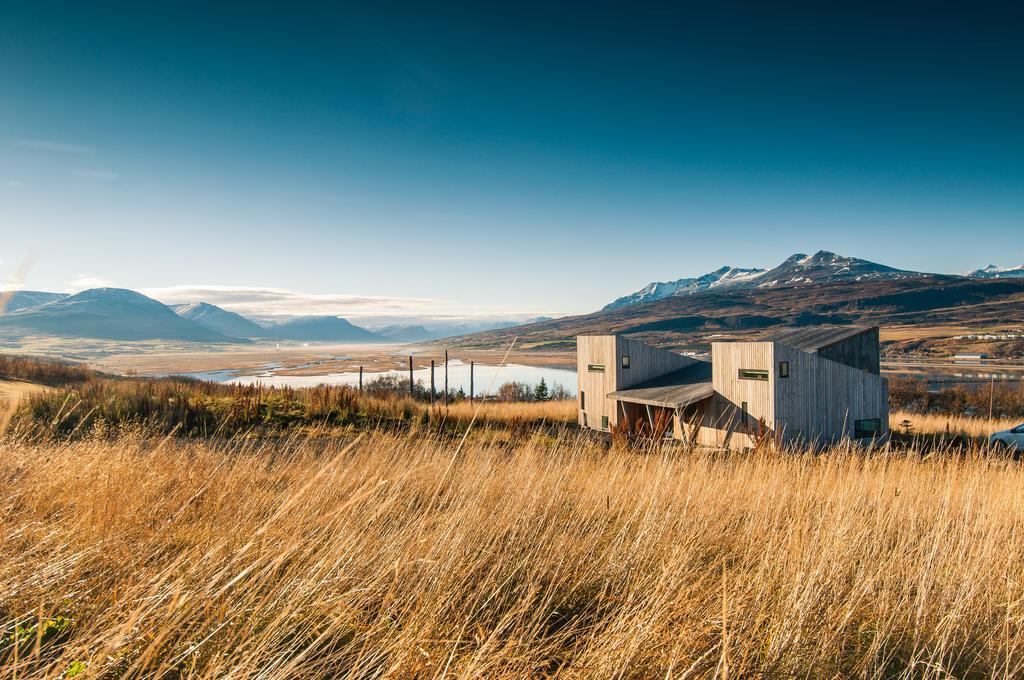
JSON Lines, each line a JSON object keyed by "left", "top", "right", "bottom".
{"left": 455, "top": 275, "right": 1024, "bottom": 349}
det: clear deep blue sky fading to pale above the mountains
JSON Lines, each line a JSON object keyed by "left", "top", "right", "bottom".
{"left": 0, "top": 2, "right": 1024, "bottom": 317}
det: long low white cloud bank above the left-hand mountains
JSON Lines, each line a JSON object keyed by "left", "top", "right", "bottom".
{"left": 140, "top": 285, "right": 561, "bottom": 324}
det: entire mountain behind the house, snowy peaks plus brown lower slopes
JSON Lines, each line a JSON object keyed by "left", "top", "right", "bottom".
{"left": 453, "top": 251, "right": 1024, "bottom": 349}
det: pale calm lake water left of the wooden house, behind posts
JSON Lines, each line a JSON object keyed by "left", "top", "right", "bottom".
{"left": 188, "top": 360, "right": 577, "bottom": 395}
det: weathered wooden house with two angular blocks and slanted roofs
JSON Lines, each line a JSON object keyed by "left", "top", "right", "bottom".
{"left": 577, "top": 327, "right": 889, "bottom": 449}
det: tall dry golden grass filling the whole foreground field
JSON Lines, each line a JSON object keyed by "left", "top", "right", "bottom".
{"left": 6, "top": 431, "right": 1024, "bottom": 680}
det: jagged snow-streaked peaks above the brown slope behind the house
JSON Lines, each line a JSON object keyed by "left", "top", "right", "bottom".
{"left": 604, "top": 250, "right": 932, "bottom": 310}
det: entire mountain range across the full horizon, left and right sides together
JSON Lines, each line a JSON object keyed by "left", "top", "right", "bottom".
{"left": 0, "top": 251, "right": 1024, "bottom": 346}
